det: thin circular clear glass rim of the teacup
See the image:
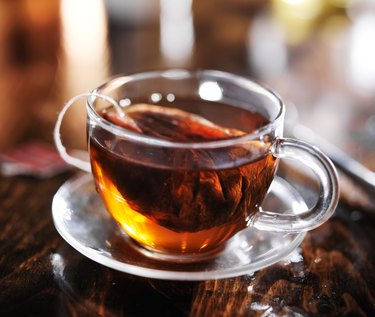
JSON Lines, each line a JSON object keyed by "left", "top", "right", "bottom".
{"left": 86, "top": 69, "right": 285, "bottom": 149}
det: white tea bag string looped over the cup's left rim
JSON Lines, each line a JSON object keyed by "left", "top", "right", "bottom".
{"left": 53, "top": 92, "right": 127, "bottom": 173}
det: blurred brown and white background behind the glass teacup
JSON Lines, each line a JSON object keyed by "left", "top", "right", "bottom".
{"left": 0, "top": 0, "right": 375, "bottom": 170}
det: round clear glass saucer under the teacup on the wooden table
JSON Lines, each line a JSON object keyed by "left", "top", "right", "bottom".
{"left": 52, "top": 174, "right": 307, "bottom": 281}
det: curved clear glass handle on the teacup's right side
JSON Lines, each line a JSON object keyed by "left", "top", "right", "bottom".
{"left": 253, "top": 138, "right": 339, "bottom": 232}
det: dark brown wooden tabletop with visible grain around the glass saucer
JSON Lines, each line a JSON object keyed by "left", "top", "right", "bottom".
{"left": 0, "top": 174, "right": 375, "bottom": 316}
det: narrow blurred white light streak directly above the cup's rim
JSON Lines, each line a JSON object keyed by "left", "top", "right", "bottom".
{"left": 160, "top": 0, "right": 194, "bottom": 65}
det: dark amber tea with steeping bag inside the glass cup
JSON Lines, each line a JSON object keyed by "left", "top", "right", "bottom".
{"left": 89, "top": 100, "right": 277, "bottom": 253}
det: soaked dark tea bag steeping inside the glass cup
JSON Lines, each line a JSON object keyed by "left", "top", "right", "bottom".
{"left": 103, "top": 104, "right": 270, "bottom": 232}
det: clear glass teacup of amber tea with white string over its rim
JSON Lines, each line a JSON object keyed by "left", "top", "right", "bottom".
{"left": 55, "top": 70, "right": 339, "bottom": 262}
